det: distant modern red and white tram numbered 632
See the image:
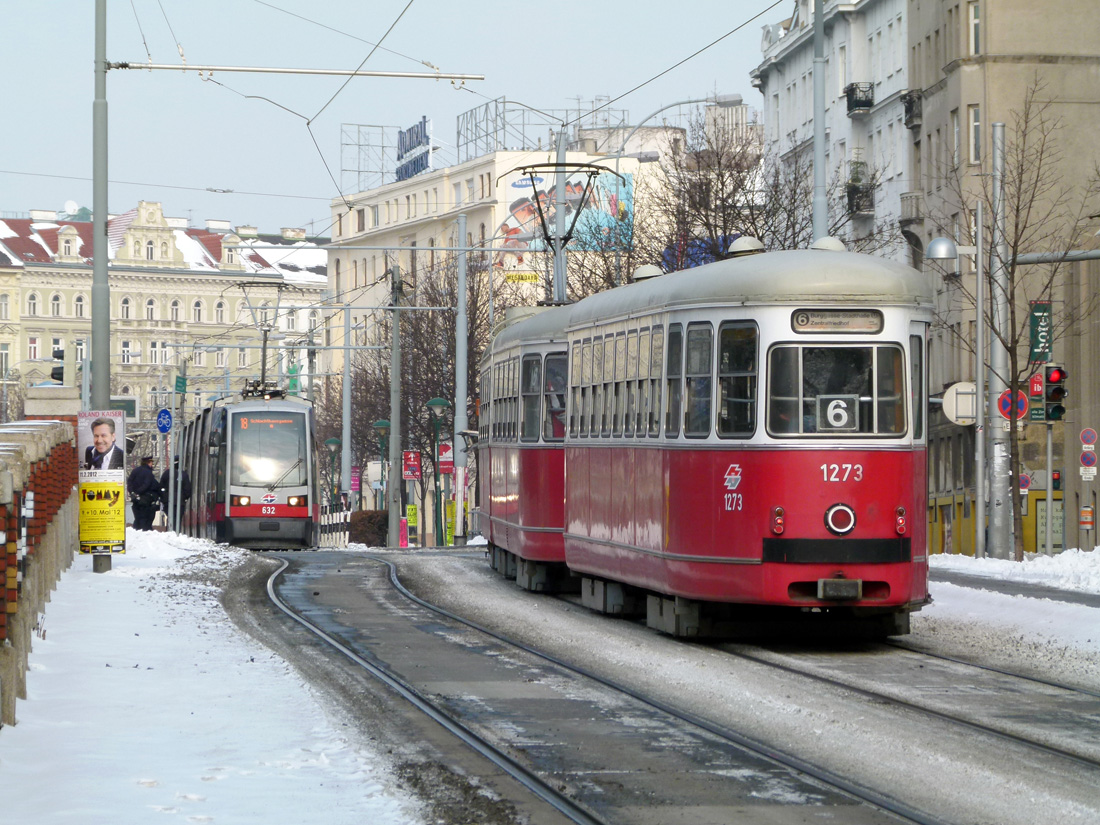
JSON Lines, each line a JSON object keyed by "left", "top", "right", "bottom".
{"left": 180, "top": 382, "right": 320, "bottom": 550}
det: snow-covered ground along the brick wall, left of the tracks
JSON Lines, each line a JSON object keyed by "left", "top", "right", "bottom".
{"left": 0, "top": 530, "right": 421, "bottom": 825}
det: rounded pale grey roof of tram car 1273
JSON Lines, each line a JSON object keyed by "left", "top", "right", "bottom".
{"left": 565, "top": 250, "right": 933, "bottom": 329}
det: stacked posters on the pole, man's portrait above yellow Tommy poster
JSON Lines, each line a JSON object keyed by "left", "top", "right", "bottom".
{"left": 76, "top": 409, "right": 127, "bottom": 553}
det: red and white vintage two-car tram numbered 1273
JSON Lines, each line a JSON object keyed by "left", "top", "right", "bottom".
{"left": 479, "top": 249, "right": 933, "bottom": 636}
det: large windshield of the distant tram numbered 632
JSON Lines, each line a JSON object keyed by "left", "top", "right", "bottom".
{"left": 230, "top": 410, "right": 309, "bottom": 490}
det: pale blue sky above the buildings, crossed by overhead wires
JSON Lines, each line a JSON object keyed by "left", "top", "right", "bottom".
{"left": 0, "top": 0, "right": 774, "bottom": 232}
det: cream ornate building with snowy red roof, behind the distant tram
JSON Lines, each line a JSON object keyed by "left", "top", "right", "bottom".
{"left": 0, "top": 201, "right": 327, "bottom": 459}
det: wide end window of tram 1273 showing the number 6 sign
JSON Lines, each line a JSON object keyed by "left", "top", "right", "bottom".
{"left": 768, "top": 344, "right": 906, "bottom": 437}
